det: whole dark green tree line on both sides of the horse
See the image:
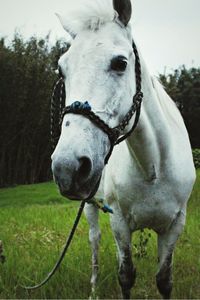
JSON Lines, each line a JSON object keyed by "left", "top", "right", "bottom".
{"left": 0, "top": 34, "right": 200, "bottom": 187}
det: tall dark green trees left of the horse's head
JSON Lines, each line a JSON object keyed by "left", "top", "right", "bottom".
{"left": 0, "top": 34, "right": 68, "bottom": 186}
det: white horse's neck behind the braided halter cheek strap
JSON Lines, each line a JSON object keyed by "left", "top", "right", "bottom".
{"left": 127, "top": 60, "right": 169, "bottom": 181}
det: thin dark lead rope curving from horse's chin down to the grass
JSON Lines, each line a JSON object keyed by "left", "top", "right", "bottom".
{"left": 22, "top": 201, "right": 85, "bottom": 290}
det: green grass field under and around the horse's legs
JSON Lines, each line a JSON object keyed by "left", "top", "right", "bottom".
{"left": 0, "top": 172, "right": 200, "bottom": 299}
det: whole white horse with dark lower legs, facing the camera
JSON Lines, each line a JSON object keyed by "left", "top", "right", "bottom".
{"left": 52, "top": 0, "right": 195, "bottom": 298}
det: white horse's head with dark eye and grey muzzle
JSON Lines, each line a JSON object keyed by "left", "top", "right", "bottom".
{"left": 52, "top": 0, "right": 136, "bottom": 200}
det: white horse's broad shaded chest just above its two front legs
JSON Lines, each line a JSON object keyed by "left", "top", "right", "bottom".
{"left": 110, "top": 185, "right": 181, "bottom": 232}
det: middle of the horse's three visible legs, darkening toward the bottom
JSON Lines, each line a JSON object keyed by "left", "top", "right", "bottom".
{"left": 111, "top": 209, "right": 136, "bottom": 299}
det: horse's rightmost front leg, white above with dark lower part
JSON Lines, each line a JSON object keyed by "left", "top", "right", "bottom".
{"left": 156, "top": 211, "right": 185, "bottom": 299}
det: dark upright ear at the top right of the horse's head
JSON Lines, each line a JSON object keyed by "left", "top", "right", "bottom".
{"left": 113, "top": 0, "right": 132, "bottom": 26}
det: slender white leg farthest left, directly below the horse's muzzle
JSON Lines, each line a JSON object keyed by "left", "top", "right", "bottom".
{"left": 84, "top": 204, "right": 101, "bottom": 295}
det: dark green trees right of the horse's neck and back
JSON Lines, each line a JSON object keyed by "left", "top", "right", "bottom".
{"left": 160, "top": 66, "right": 200, "bottom": 148}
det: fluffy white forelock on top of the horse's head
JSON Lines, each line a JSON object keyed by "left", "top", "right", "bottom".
{"left": 57, "top": 0, "right": 117, "bottom": 35}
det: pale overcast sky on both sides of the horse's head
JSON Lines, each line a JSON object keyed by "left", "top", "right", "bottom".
{"left": 0, "top": 0, "right": 200, "bottom": 74}
